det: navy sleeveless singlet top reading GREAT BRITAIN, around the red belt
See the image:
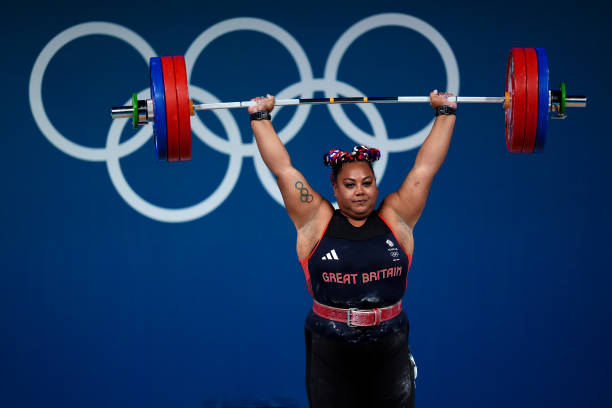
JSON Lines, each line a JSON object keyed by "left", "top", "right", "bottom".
{"left": 301, "top": 210, "right": 412, "bottom": 341}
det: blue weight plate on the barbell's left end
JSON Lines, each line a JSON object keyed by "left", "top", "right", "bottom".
{"left": 150, "top": 57, "right": 168, "bottom": 160}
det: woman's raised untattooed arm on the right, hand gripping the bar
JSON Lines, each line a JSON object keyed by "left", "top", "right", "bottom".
{"left": 381, "top": 91, "right": 457, "bottom": 229}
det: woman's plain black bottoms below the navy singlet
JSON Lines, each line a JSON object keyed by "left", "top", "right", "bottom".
{"left": 305, "top": 325, "right": 414, "bottom": 408}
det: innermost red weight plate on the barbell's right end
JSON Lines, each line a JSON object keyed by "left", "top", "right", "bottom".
{"left": 506, "top": 48, "right": 527, "bottom": 153}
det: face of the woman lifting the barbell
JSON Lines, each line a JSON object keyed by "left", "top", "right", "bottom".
{"left": 333, "top": 161, "right": 378, "bottom": 220}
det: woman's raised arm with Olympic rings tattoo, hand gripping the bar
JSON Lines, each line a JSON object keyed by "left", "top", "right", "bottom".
{"left": 249, "top": 95, "right": 329, "bottom": 231}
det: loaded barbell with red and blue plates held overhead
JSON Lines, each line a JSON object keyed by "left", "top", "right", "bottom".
{"left": 111, "top": 48, "right": 587, "bottom": 161}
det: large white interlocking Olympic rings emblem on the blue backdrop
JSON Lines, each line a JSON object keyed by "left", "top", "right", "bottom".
{"left": 29, "top": 13, "right": 459, "bottom": 222}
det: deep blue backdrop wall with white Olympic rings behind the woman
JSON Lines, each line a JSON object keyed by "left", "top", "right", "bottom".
{"left": 0, "top": 0, "right": 612, "bottom": 408}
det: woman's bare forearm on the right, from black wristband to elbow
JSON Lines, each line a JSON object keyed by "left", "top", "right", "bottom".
{"left": 414, "top": 115, "right": 456, "bottom": 175}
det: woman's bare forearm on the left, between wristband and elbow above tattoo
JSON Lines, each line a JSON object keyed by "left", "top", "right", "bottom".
{"left": 251, "top": 120, "right": 292, "bottom": 177}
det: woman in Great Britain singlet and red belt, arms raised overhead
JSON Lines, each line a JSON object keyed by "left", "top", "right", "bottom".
{"left": 249, "top": 91, "right": 457, "bottom": 408}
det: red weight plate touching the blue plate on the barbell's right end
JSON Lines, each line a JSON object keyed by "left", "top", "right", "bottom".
{"left": 523, "top": 48, "right": 539, "bottom": 153}
